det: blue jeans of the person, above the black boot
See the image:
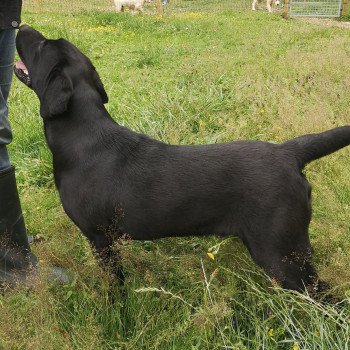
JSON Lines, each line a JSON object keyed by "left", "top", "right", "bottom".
{"left": 0, "top": 29, "right": 16, "bottom": 170}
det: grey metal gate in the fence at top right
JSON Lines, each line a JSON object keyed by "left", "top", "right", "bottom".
{"left": 287, "top": 0, "right": 342, "bottom": 17}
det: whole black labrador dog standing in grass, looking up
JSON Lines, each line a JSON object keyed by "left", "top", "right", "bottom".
{"left": 15, "top": 25, "right": 350, "bottom": 291}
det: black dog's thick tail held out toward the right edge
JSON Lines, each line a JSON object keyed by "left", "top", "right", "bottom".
{"left": 283, "top": 125, "right": 350, "bottom": 169}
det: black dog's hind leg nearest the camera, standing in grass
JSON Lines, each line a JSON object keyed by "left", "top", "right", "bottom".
{"left": 243, "top": 202, "right": 326, "bottom": 292}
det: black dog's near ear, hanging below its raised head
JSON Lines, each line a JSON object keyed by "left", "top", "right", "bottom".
{"left": 40, "top": 69, "right": 73, "bottom": 118}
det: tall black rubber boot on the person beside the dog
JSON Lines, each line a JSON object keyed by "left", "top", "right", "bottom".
{"left": 0, "top": 167, "right": 37, "bottom": 286}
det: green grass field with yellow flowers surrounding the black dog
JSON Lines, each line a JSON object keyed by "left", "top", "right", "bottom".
{"left": 0, "top": 1, "right": 350, "bottom": 350}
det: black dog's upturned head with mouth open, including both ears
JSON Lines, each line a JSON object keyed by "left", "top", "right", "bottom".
{"left": 14, "top": 25, "right": 108, "bottom": 118}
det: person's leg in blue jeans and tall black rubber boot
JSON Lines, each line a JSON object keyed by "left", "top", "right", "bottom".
{"left": 0, "top": 29, "right": 36, "bottom": 283}
